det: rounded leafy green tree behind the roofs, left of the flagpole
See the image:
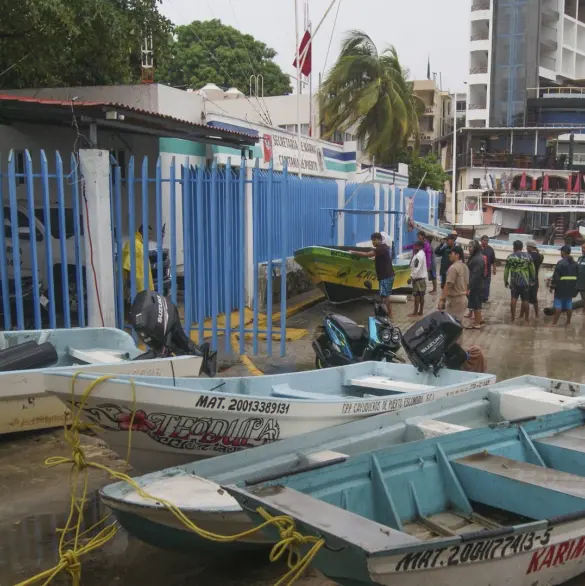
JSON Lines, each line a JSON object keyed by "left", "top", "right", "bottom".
{"left": 160, "top": 19, "right": 292, "bottom": 96}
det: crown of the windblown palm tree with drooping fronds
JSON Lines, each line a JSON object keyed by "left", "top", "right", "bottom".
{"left": 319, "top": 30, "right": 424, "bottom": 165}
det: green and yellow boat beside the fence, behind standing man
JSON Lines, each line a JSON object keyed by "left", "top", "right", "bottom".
{"left": 295, "top": 246, "right": 411, "bottom": 303}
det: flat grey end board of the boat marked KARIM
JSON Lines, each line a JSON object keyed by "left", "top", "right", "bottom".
{"left": 224, "top": 486, "right": 420, "bottom": 554}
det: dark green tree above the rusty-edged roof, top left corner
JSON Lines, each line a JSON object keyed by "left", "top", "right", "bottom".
{"left": 0, "top": 0, "right": 172, "bottom": 88}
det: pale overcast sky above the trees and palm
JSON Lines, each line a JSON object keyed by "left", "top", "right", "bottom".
{"left": 161, "top": 0, "right": 470, "bottom": 91}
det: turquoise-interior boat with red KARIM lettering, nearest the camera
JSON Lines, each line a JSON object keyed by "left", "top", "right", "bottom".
{"left": 225, "top": 409, "right": 585, "bottom": 586}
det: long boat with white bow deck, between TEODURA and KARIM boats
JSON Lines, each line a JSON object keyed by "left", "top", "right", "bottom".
{"left": 100, "top": 376, "right": 585, "bottom": 552}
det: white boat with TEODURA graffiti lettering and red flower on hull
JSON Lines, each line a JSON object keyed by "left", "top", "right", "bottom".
{"left": 45, "top": 362, "right": 495, "bottom": 472}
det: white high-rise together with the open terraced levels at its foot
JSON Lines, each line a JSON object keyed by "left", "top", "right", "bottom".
{"left": 442, "top": 0, "right": 585, "bottom": 229}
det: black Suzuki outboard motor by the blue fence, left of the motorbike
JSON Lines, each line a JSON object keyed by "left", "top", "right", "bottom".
{"left": 130, "top": 291, "right": 217, "bottom": 376}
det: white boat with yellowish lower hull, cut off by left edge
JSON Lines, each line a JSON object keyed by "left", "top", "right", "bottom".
{"left": 0, "top": 328, "right": 202, "bottom": 435}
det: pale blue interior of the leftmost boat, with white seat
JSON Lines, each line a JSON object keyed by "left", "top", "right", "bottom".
{"left": 0, "top": 328, "right": 142, "bottom": 367}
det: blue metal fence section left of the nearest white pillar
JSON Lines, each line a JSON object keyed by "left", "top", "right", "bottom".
{"left": 0, "top": 150, "right": 87, "bottom": 330}
